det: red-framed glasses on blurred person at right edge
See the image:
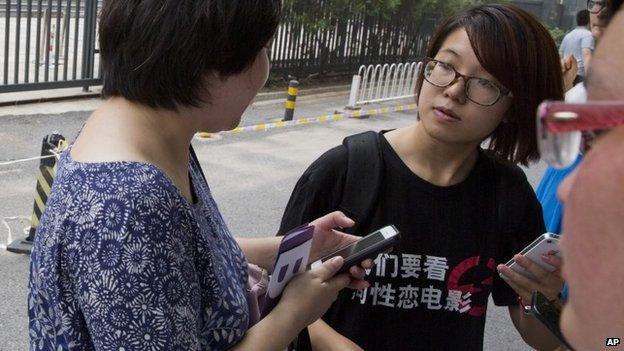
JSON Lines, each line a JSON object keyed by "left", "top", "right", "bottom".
{"left": 537, "top": 101, "right": 624, "bottom": 168}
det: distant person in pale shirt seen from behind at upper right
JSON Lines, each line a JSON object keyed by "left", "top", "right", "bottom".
{"left": 559, "top": 9, "right": 594, "bottom": 84}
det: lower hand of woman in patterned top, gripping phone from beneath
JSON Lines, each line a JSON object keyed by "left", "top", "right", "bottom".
{"left": 275, "top": 257, "right": 351, "bottom": 328}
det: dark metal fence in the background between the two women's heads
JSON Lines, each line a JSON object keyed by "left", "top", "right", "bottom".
{"left": 271, "top": 0, "right": 435, "bottom": 76}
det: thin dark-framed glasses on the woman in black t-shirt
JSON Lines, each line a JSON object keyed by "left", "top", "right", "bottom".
{"left": 423, "top": 58, "right": 511, "bottom": 106}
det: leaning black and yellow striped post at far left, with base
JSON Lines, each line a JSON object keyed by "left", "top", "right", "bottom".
{"left": 7, "top": 133, "right": 65, "bottom": 254}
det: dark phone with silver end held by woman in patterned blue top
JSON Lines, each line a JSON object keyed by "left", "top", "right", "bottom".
{"left": 309, "top": 225, "right": 401, "bottom": 274}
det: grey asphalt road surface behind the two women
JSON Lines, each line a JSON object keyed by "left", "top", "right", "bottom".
{"left": 0, "top": 93, "right": 544, "bottom": 351}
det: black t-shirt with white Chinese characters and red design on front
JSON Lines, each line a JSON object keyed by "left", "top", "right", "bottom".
{"left": 280, "top": 132, "right": 544, "bottom": 350}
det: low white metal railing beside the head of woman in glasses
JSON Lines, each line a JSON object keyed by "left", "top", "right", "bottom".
{"left": 347, "top": 62, "right": 421, "bottom": 108}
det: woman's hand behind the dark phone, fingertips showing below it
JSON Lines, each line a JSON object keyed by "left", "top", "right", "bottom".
{"left": 309, "top": 211, "right": 373, "bottom": 289}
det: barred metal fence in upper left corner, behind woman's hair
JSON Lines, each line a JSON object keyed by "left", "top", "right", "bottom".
{"left": 0, "top": 0, "right": 101, "bottom": 93}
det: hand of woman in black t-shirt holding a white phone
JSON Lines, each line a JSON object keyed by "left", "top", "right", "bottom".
{"left": 497, "top": 255, "right": 563, "bottom": 304}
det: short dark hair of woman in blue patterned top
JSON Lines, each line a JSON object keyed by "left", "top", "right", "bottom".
{"left": 99, "top": 0, "right": 281, "bottom": 110}
